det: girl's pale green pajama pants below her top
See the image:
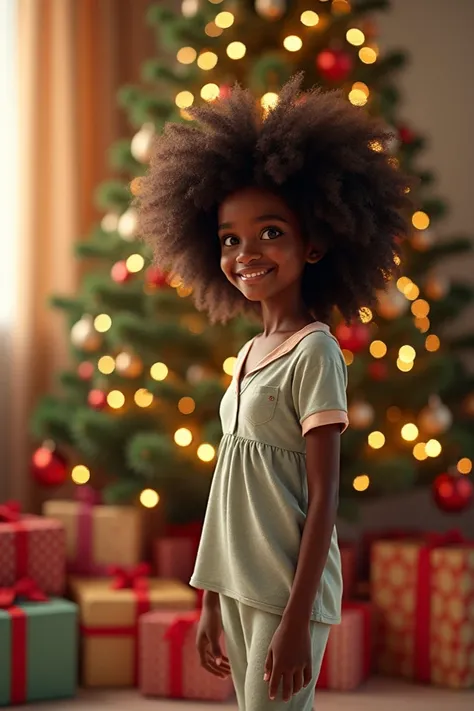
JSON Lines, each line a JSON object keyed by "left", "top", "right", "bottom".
{"left": 219, "top": 595, "right": 330, "bottom": 711}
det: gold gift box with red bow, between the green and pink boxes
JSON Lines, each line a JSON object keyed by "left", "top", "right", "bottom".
{"left": 70, "top": 566, "right": 196, "bottom": 687}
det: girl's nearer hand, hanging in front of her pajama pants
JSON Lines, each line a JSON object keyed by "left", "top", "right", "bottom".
{"left": 263, "top": 619, "right": 312, "bottom": 701}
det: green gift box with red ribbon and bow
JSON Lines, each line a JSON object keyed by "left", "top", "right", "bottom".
{"left": 0, "top": 579, "right": 78, "bottom": 706}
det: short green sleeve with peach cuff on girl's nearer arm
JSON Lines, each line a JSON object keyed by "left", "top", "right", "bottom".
{"left": 292, "top": 331, "right": 349, "bottom": 435}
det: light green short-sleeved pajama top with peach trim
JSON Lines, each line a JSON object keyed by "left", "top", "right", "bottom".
{"left": 190, "top": 322, "right": 348, "bottom": 624}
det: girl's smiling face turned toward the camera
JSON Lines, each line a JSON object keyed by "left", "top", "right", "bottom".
{"left": 218, "top": 187, "right": 317, "bottom": 302}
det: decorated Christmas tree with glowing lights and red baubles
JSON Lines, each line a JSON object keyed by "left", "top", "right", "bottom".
{"left": 33, "top": 0, "right": 474, "bottom": 521}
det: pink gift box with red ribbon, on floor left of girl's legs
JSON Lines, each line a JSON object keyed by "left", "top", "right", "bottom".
{"left": 139, "top": 610, "right": 234, "bottom": 701}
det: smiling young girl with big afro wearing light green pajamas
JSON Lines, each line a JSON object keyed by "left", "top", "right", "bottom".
{"left": 139, "top": 76, "right": 409, "bottom": 711}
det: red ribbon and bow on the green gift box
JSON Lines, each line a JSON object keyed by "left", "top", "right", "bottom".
{"left": 0, "top": 578, "right": 48, "bottom": 704}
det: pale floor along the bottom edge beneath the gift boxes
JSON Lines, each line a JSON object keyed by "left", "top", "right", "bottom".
{"left": 16, "top": 678, "right": 474, "bottom": 711}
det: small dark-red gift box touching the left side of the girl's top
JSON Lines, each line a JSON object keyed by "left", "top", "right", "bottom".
{"left": 153, "top": 522, "right": 202, "bottom": 584}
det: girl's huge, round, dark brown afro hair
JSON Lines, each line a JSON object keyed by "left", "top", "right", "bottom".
{"left": 136, "top": 74, "right": 411, "bottom": 322}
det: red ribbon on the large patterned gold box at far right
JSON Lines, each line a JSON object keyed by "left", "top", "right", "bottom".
{"left": 414, "top": 529, "right": 468, "bottom": 683}
